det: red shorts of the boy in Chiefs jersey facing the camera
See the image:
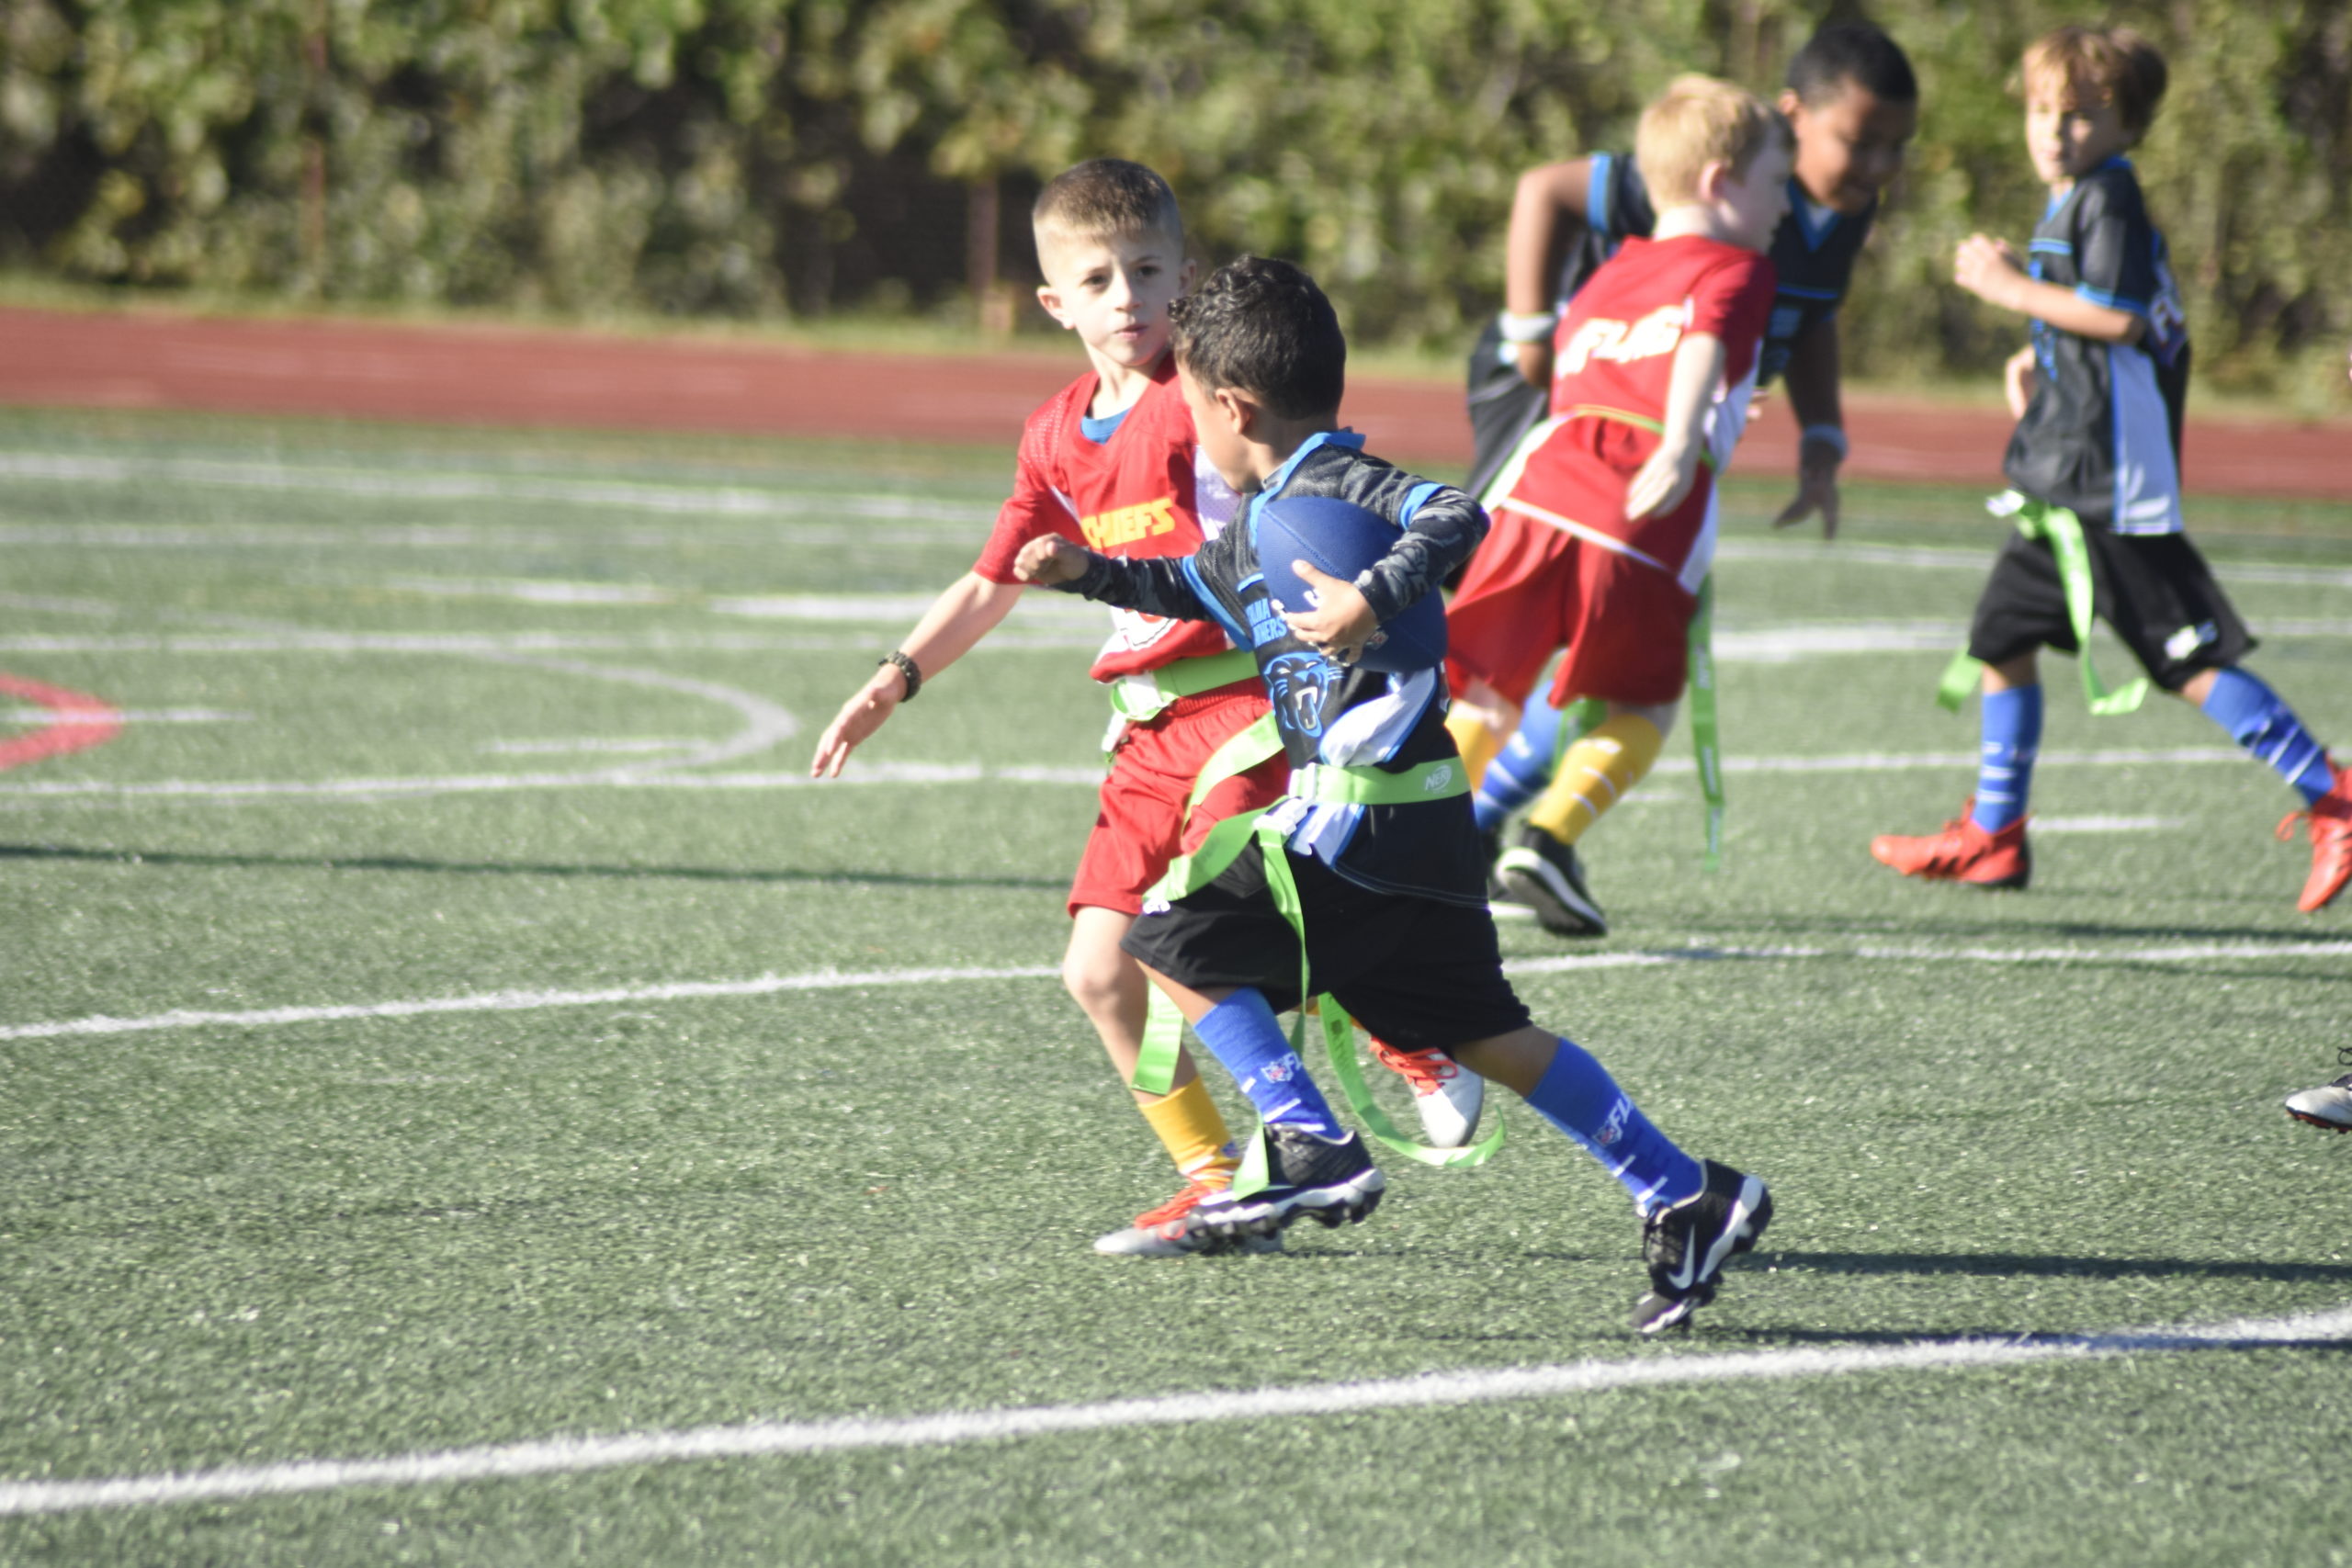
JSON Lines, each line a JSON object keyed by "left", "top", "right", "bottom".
{"left": 1068, "top": 680, "right": 1291, "bottom": 915}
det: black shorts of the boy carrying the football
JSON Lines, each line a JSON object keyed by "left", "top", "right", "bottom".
{"left": 1120, "top": 840, "right": 1532, "bottom": 1051}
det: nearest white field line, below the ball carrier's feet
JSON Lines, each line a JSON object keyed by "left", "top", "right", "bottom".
{"left": 0, "top": 1307, "right": 2352, "bottom": 1517}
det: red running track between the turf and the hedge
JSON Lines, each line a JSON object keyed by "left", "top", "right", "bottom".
{"left": 0, "top": 310, "right": 2352, "bottom": 501}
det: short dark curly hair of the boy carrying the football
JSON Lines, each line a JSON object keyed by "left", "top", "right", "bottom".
{"left": 1169, "top": 256, "right": 1348, "bottom": 419}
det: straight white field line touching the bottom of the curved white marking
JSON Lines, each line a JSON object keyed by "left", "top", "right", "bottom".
{"left": 0, "top": 747, "right": 2246, "bottom": 802}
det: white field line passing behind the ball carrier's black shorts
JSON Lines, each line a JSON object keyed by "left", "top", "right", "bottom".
{"left": 0, "top": 938, "right": 2352, "bottom": 1042}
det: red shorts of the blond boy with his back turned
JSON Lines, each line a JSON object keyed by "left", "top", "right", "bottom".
{"left": 1446, "top": 508, "right": 1698, "bottom": 707}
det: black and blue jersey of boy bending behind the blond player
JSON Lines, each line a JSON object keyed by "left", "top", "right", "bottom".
{"left": 1463, "top": 152, "right": 1879, "bottom": 496}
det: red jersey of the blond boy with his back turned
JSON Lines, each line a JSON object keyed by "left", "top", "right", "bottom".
{"left": 1503, "top": 235, "right": 1773, "bottom": 590}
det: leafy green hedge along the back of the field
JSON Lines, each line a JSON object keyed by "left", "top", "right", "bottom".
{"left": 0, "top": 0, "right": 2352, "bottom": 386}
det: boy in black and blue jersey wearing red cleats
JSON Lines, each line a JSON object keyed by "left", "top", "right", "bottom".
{"left": 1870, "top": 26, "right": 2352, "bottom": 912}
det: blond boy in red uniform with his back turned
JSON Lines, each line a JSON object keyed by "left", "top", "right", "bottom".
{"left": 1446, "top": 75, "right": 1792, "bottom": 936}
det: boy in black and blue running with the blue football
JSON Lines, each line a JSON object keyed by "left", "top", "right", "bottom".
{"left": 1016, "top": 256, "right": 1771, "bottom": 1333}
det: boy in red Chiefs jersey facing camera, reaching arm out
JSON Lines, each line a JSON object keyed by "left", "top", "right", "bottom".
{"left": 809, "top": 157, "right": 1477, "bottom": 1258}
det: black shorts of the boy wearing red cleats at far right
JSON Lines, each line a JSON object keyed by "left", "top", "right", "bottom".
{"left": 1969, "top": 522, "right": 2256, "bottom": 691}
